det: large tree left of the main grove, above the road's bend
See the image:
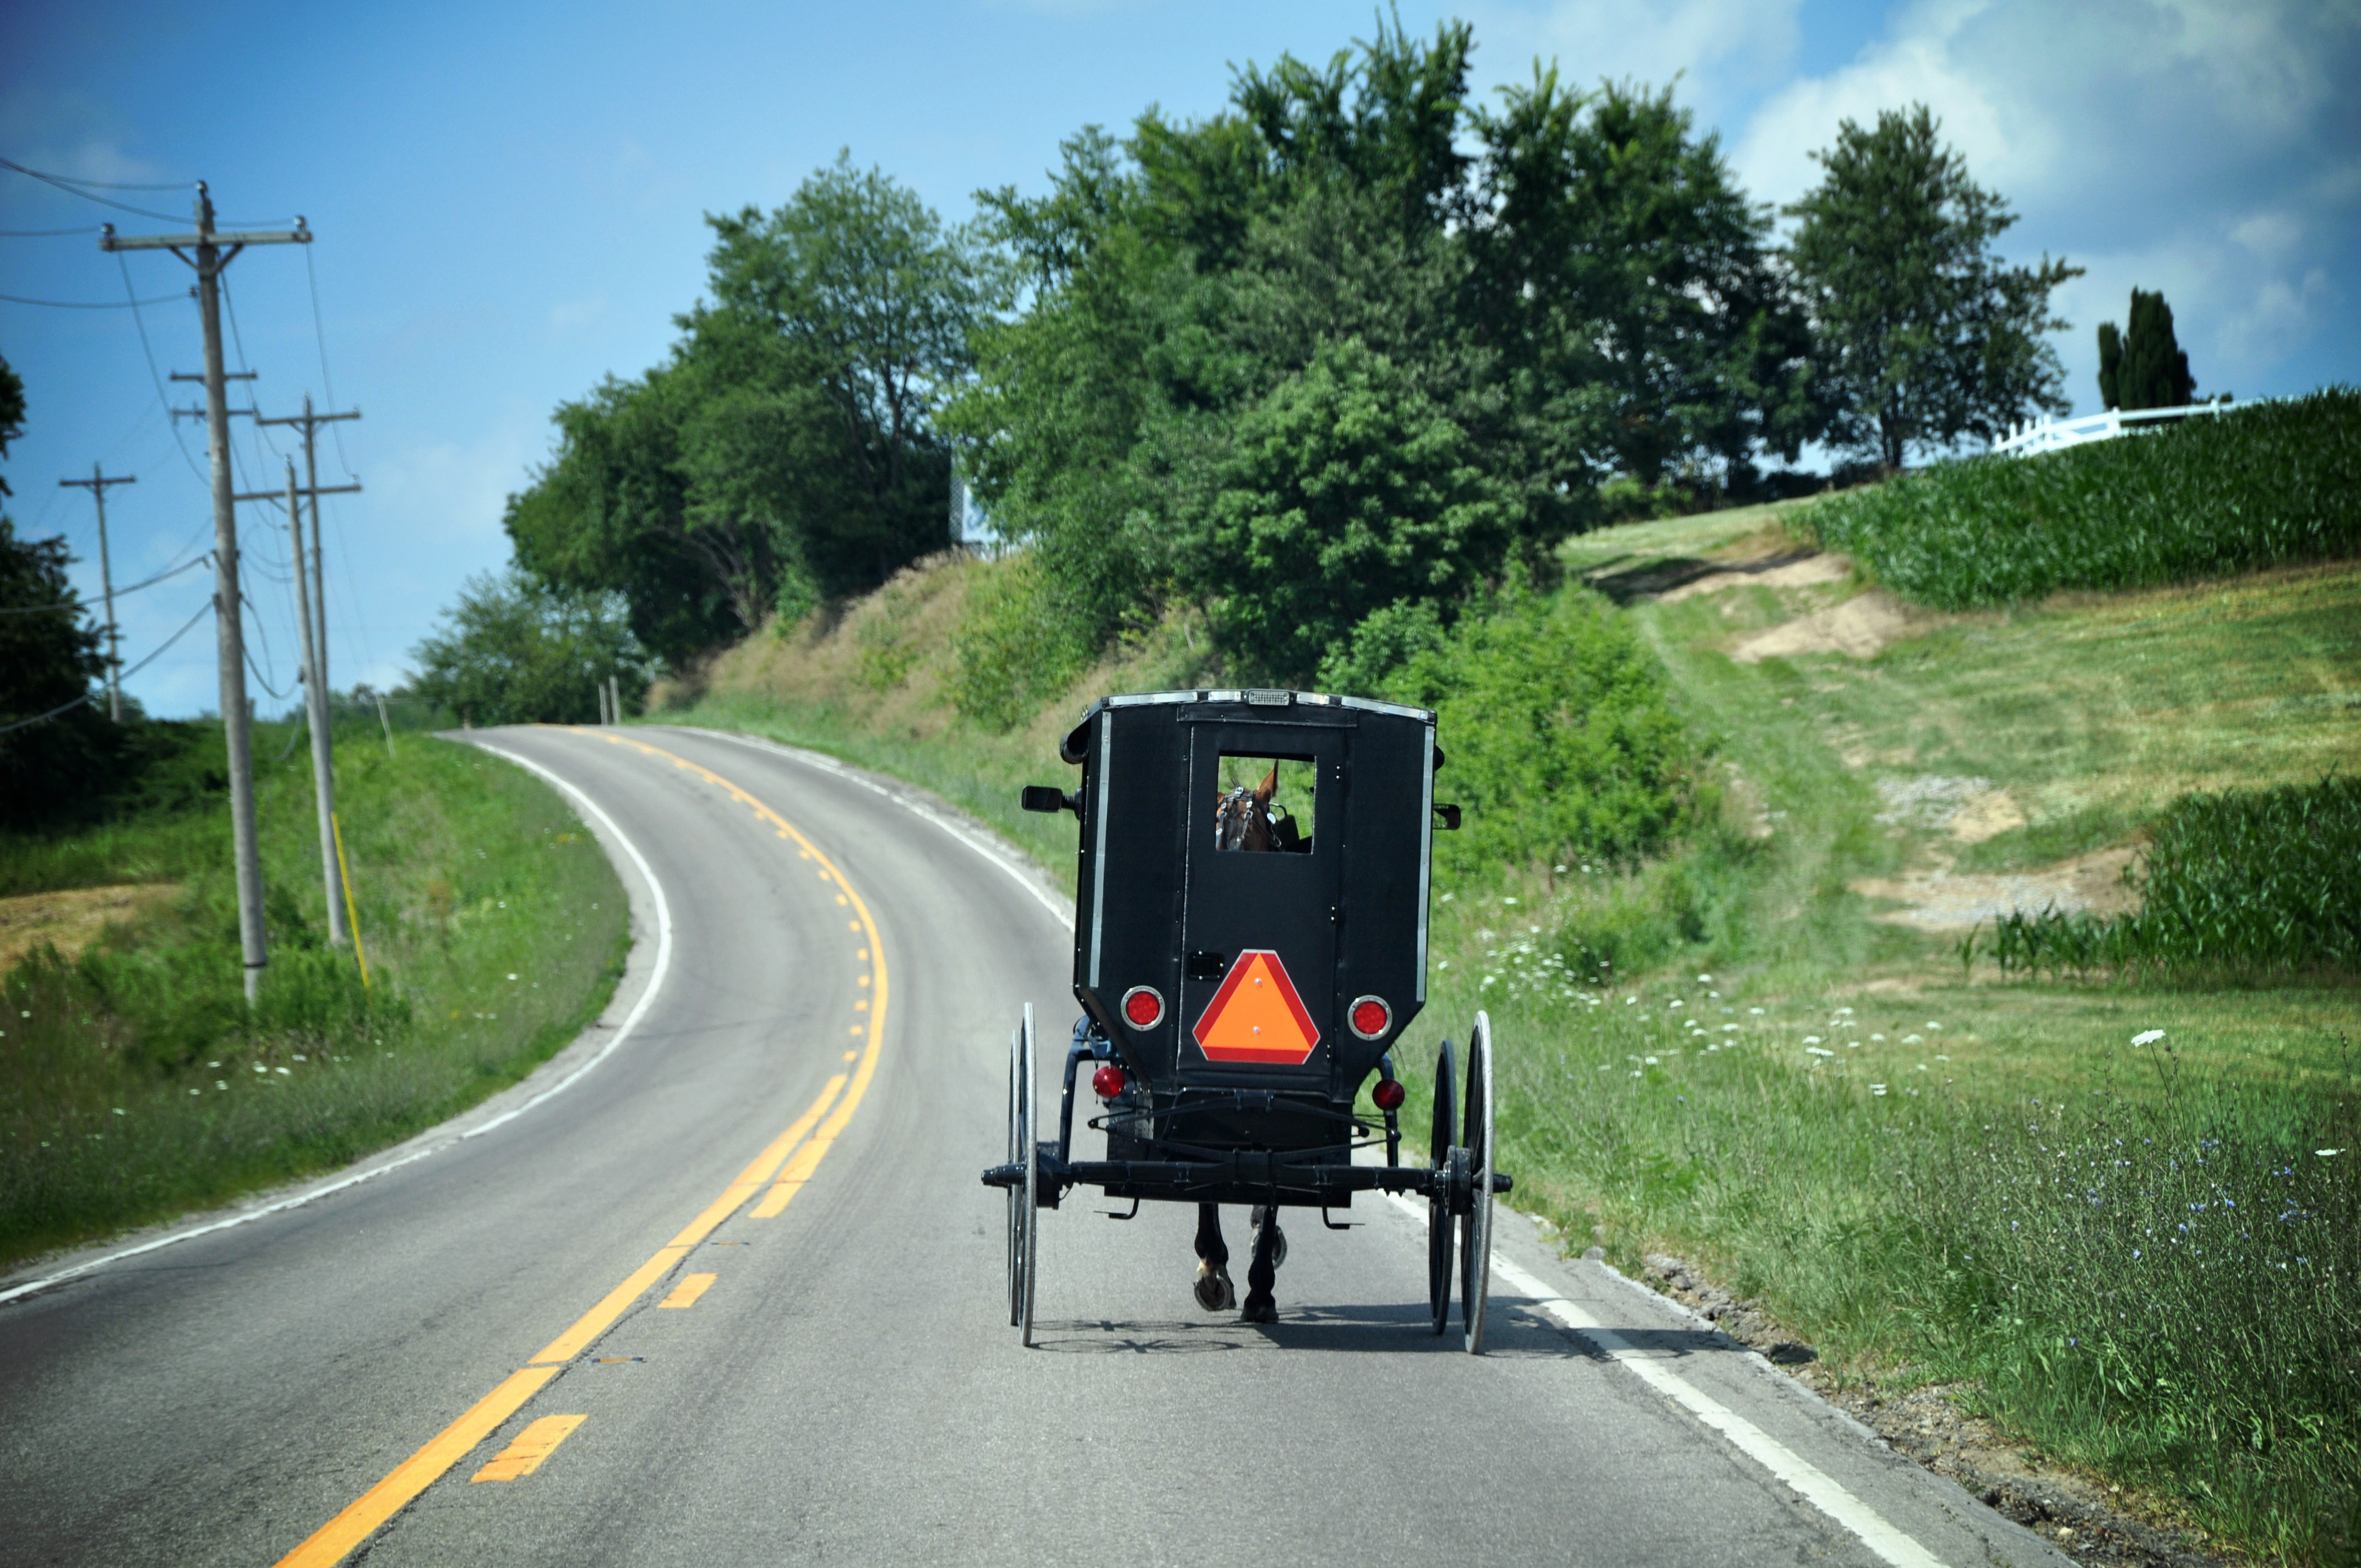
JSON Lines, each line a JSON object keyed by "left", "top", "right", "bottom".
{"left": 505, "top": 158, "right": 1001, "bottom": 661}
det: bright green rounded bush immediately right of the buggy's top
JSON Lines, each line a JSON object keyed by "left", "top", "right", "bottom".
{"left": 1391, "top": 588, "right": 1695, "bottom": 881}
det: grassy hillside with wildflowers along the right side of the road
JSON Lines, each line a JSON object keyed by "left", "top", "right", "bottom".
{"left": 678, "top": 401, "right": 2361, "bottom": 1561}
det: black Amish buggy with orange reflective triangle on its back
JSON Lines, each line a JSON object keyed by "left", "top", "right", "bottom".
{"left": 984, "top": 689, "right": 1509, "bottom": 1351}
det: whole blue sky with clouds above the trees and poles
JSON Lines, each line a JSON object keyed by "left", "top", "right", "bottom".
{"left": 0, "top": 0, "right": 2361, "bottom": 716}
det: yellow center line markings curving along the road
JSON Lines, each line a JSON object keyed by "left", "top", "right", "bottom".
{"left": 279, "top": 729, "right": 885, "bottom": 1568}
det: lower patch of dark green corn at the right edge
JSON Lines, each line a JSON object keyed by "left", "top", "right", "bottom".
{"left": 1965, "top": 777, "right": 2361, "bottom": 980}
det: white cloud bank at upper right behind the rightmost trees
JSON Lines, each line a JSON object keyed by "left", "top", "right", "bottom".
{"left": 1733, "top": 0, "right": 2361, "bottom": 409}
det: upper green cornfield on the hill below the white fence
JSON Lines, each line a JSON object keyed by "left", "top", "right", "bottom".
{"left": 1794, "top": 387, "right": 2361, "bottom": 609}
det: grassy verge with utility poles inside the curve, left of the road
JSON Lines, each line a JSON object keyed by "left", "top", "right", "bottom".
{"left": 0, "top": 725, "right": 628, "bottom": 1261}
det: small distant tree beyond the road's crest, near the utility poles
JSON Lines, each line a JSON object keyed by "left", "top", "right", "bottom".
{"left": 411, "top": 567, "right": 649, "bottom": 725}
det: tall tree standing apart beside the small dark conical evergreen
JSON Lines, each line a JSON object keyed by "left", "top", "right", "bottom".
{"left": 1787, "top": 104, "right": 2082, "bottom": 470}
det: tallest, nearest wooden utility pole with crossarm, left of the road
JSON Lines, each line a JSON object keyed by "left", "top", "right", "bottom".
{"left": 99, "top": 182, "right": 312, "bottom": 1006}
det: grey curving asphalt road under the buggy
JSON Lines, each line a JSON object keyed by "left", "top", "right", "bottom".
{"left": 0, "top": 729, "right": 2064, "bottom": 1568}
